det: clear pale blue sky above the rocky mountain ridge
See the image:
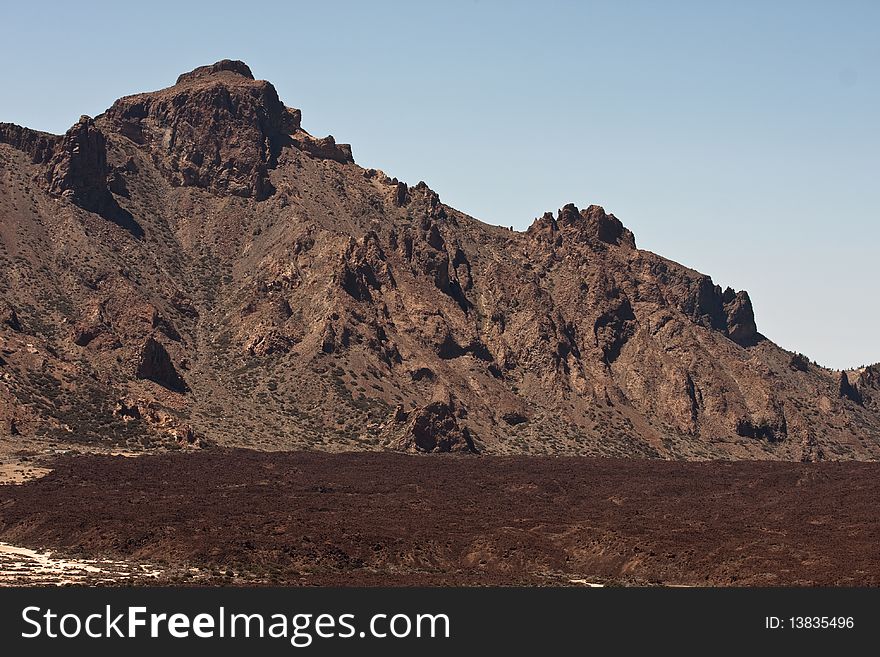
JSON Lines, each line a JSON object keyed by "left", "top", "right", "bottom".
{"left": 0, "top": 0, "right": 880, "bottom": 367}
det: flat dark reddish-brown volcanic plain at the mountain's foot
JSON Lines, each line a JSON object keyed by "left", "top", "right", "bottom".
{"left": 0, "top": 449, "right": 880, "bottom": 586}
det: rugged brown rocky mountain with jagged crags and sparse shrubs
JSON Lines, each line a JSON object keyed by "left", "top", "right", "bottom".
{"left": 0, "top": 60, "right": 880, "bottom": 460}
